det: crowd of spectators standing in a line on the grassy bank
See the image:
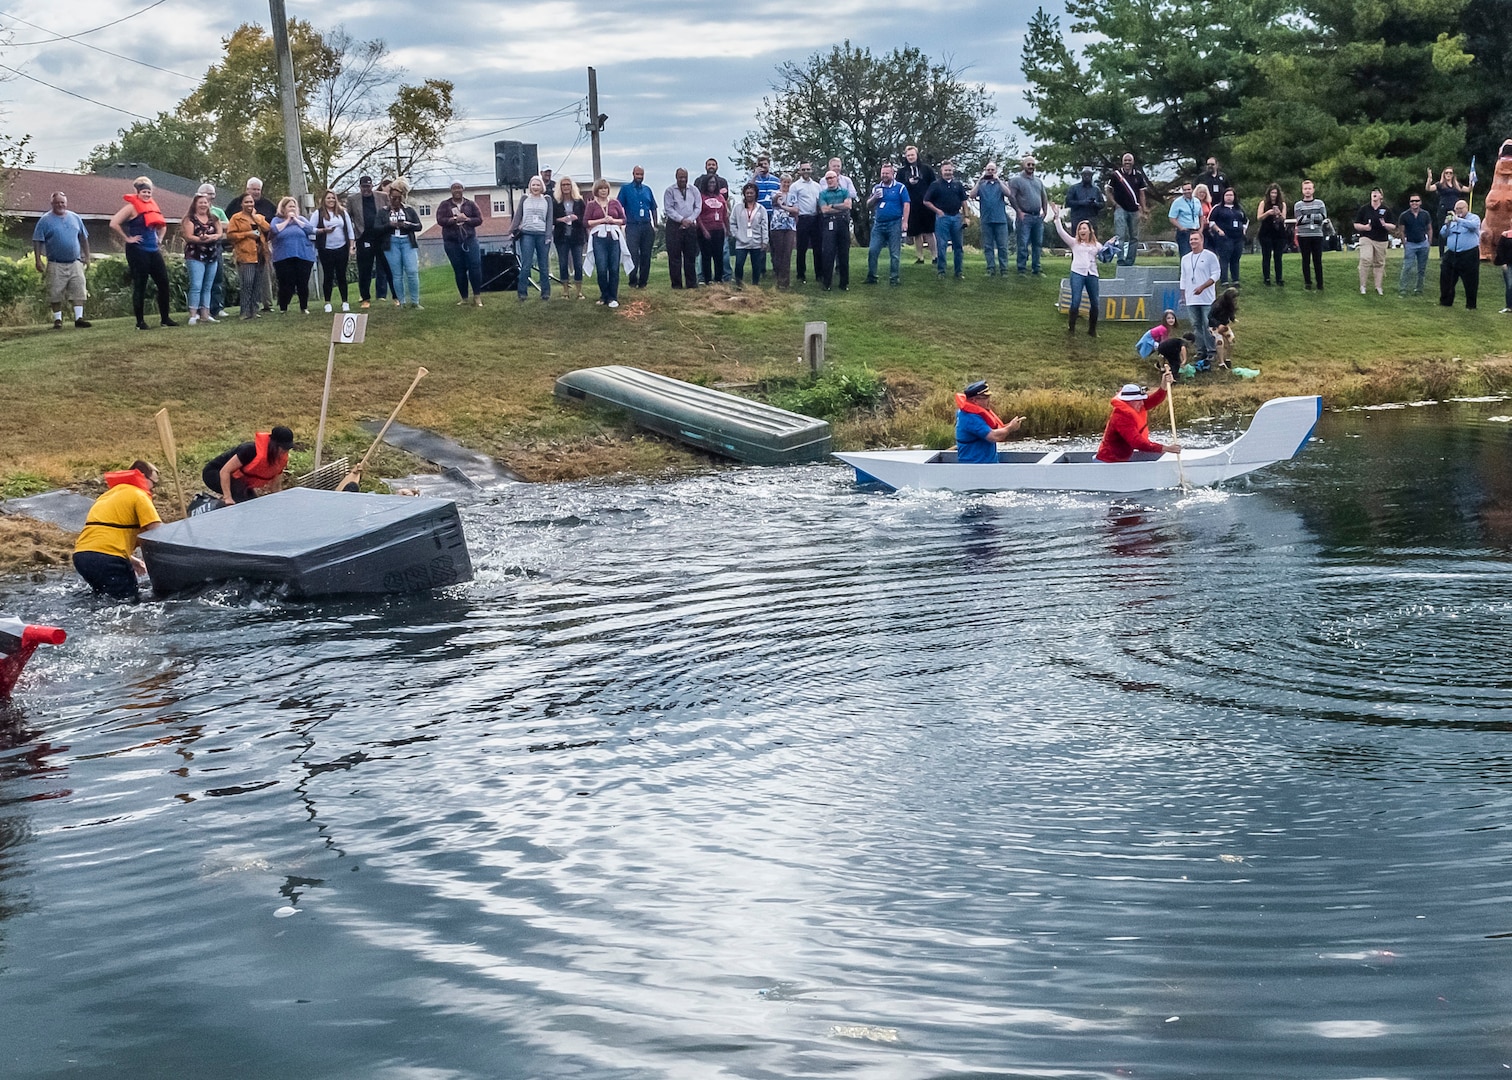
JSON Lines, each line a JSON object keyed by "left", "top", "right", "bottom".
{"left": 33, "top": 145, "right": 1512, "bottom": 329}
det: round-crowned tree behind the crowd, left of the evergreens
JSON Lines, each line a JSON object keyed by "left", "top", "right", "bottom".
{"left": 732, "top": 41, "right": 999, "bottom": 241}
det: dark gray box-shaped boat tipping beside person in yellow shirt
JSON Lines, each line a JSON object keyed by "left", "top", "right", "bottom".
{"left": 141, "top": 487, "right": 472, "bottom": 597}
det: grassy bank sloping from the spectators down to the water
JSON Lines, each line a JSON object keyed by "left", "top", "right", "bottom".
{"left": 0, "top": 251, "right": 1512, "bottom": 486}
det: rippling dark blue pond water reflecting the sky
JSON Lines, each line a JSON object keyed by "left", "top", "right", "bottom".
{"left": 0, "top": 402, "right": 1512, "bottom": 1080}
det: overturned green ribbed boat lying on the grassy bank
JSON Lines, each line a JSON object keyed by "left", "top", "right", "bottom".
{"left": 556, "top": 365, "right": 830, "bottom": 464}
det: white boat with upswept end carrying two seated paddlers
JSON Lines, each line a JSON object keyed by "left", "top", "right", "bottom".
{"left": 835, "top": 395, "right": 1323, "bottom": 492}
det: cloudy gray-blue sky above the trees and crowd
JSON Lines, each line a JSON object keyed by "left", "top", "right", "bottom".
{"left": 0, "top": 0, "right": 1058, "bottom": 185}
